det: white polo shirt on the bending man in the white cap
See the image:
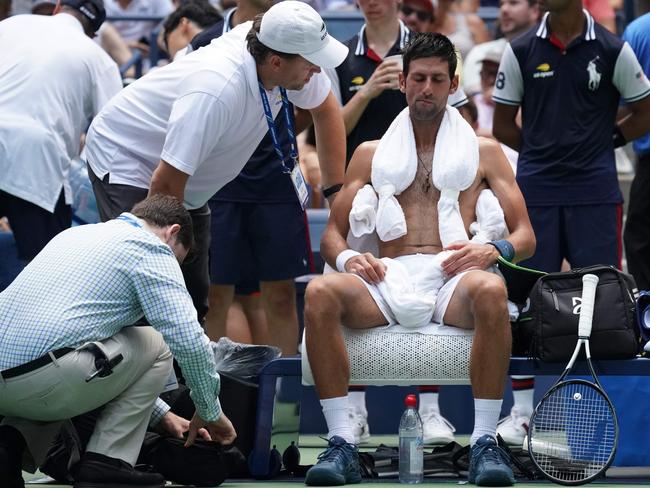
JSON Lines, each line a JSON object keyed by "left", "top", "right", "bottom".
{"left": 86, "top": 22, "right": 330, "bottom": 209}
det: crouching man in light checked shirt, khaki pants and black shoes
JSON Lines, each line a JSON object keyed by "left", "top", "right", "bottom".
{"left": 0, "top": 195, "right": 236, "bottom": 488}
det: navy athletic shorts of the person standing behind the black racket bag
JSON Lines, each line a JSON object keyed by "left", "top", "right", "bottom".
{"left": 519, "top": 203, "right": 623, "bottom": 273}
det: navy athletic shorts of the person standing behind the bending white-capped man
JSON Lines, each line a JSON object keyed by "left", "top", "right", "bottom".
{"left": 210, "top": 200, "right": 311, "bottom": 285}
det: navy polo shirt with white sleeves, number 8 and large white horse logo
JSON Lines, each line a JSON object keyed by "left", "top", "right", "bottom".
{"left": 493, "top": 11, "right": 650, "bottom": 205}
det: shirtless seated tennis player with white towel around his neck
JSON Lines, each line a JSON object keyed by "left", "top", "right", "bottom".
{"left": 305, "top": 34, "right": 535, "bottom": 486}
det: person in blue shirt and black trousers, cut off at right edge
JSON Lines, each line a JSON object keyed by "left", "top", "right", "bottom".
{"left": 623, "top": 13, "right": 650, "bottom": 290}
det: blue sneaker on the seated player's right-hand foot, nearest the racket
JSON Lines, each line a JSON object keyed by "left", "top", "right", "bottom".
{"left": 469, "top": 434, "right": 515, "bottom": 486}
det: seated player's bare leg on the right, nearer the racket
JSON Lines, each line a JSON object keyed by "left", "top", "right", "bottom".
{"left": 444, "top": 271, "right": 512, "bottom": 400}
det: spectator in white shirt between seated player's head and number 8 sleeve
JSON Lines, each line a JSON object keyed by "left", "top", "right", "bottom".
{"left": 462, "top": 0, "right": 539, "bottom": 95}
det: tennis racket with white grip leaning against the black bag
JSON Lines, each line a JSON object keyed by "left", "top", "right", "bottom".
{"left": 528, "top": 274, "right": 618, "bottom": 485}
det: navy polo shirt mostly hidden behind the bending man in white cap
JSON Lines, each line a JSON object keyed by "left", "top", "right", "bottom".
{"left": 190, "top": 9, "right": 298, "bottom": 203}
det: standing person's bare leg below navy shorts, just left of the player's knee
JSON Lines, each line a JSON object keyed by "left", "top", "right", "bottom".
{"left": 260, "top": 280, "right": 298, "bottom": 357}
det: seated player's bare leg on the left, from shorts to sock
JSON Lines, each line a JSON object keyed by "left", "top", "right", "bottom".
{"left": 305, "top": 274, "right": 388, "bottom": 399}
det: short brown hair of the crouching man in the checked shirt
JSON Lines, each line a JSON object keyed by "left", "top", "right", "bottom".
{"left": 131, "top": 195, "right": 194, "bottom": 250}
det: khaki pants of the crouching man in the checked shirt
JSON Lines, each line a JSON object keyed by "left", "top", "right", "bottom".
{"left": 0, "top": 327, "right": 172, "bottom": 471}
